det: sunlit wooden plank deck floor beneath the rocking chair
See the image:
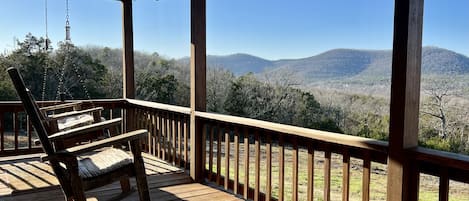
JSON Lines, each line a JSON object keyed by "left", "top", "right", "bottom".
{"left": 0, "top": 154, "right": 241, "bottom": 201}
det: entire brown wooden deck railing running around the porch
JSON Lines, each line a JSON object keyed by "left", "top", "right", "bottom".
{"left": 0, "top": 99, "right": 469, "bottom": 200}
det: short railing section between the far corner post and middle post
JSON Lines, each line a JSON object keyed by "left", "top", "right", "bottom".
{"left": 126, "top": 99, "right": 190, "bottom": 169}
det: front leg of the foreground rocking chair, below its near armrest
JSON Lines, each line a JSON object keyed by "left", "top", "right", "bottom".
{"left": 130, "top": 140, "right": 150, "bottom": 201}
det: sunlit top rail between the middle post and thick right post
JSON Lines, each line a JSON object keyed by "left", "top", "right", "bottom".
{"left": 195, "top": 112, "right": 388, "bottom": 153}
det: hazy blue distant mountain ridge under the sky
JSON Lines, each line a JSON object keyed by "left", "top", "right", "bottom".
{"left": 197, "top": 47, "right": 469, "bottom": 82}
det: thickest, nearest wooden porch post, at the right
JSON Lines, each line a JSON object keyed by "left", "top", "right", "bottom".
{"left": 387, "top": 0, "right": 423, "bottom": 200}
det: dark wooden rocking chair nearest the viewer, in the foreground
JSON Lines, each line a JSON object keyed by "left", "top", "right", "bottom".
{"left": 7, "top": 68, "right": 150, "bottom": 201}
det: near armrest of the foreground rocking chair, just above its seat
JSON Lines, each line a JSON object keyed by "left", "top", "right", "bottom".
{"left": 56, "top": 129, "right": 148, "bottom": 156}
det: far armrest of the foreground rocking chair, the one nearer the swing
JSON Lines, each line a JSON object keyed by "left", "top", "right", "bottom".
{"left": 49, "top": 118, "right": 121, "bottom": 141}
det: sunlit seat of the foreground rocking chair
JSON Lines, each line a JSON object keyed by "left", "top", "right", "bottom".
{"left": 77, "top": 148, "right": 132, "bottom": 178}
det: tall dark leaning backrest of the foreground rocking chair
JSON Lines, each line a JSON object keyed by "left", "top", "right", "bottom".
{"left": 7, "top": 67, "right": 55, "bottom": 155}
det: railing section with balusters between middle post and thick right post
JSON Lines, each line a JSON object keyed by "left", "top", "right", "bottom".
{"left": 196, "top": 112, "right": 387, "bottom": 200}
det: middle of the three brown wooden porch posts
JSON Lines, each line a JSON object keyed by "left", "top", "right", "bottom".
{"left": 190, "top": 0, "right": 207, "bottom": 182}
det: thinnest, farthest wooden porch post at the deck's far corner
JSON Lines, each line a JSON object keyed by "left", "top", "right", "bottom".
{"left": 121, "top": 0, "right": 135, "bottom": 98}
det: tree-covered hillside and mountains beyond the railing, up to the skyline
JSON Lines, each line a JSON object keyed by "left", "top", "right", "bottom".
{"left": 0, "top": 34, "right": 469, "bottom": 153}
